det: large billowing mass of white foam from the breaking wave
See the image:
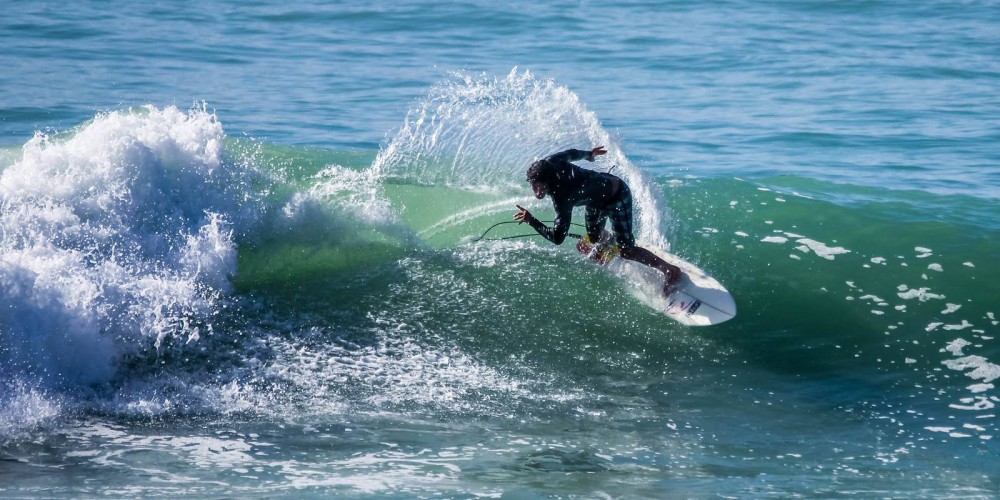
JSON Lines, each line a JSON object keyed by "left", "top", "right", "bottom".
{"left": 0, "top": 106, "right": 258, "bottom": 383}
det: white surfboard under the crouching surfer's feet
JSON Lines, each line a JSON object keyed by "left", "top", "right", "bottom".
{"left": 577, "top": 236, "right": 736, "bottom": 326}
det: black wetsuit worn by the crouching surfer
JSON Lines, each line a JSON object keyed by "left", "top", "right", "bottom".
{"left": 526, "top": 149, "right": 635, "bottom": 249}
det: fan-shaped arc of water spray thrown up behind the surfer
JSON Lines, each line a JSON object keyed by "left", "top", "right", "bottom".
{"left": 372, "top": 68, "right": 666, "bottom": 246}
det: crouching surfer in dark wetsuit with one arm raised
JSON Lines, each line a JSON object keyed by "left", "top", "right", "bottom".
{"left": 514, "top": 146, "right": 681, "bottom": 295}
